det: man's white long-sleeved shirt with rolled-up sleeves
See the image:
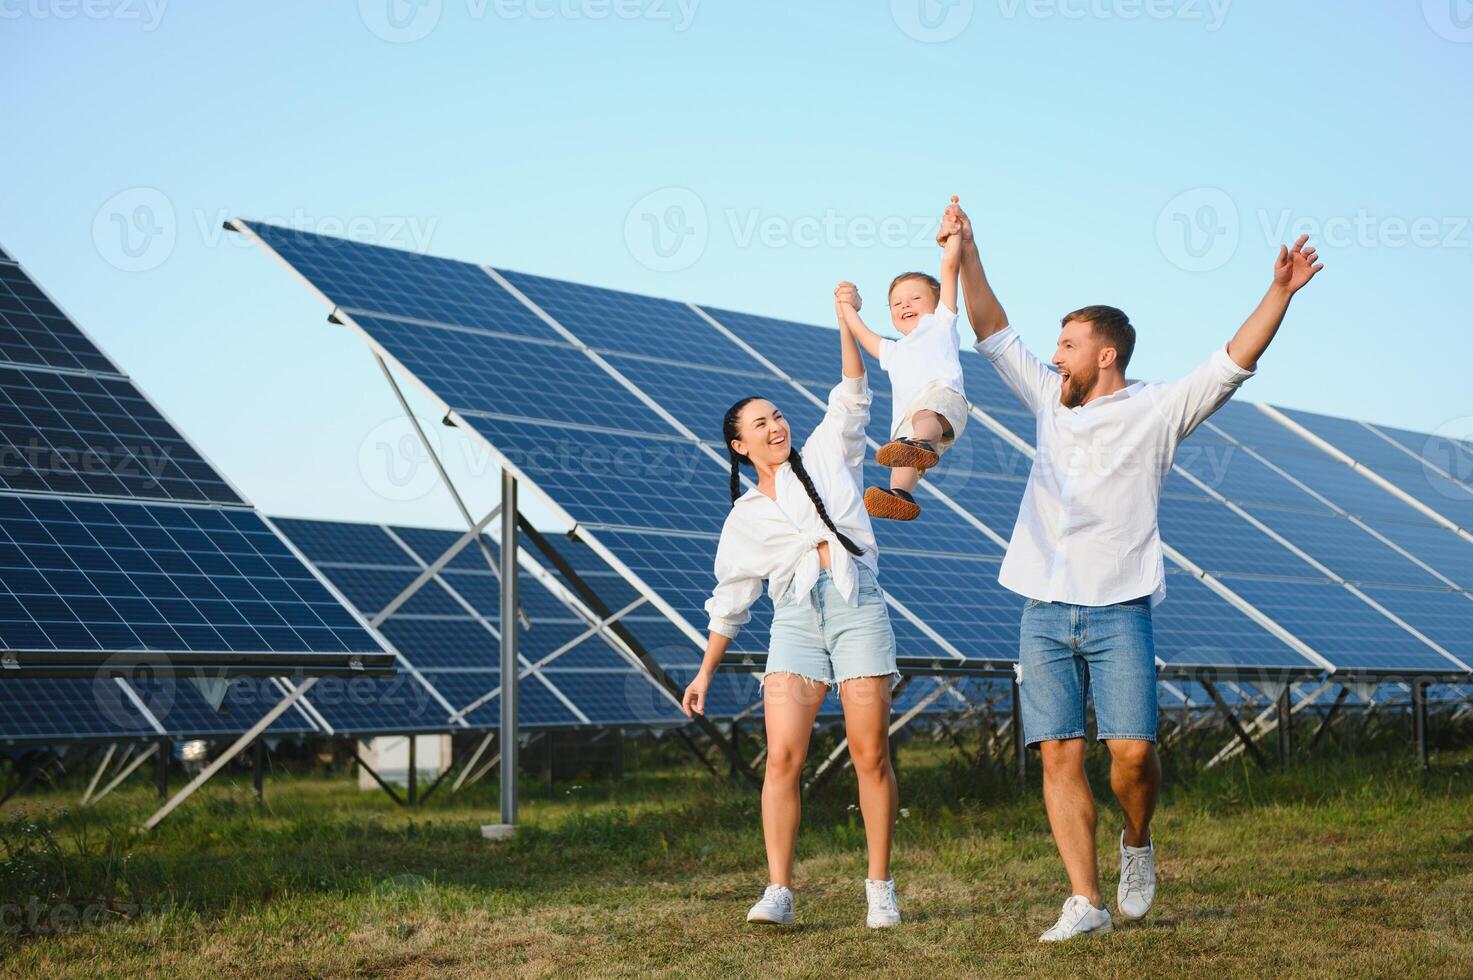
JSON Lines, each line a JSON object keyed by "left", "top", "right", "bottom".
{"left": 977, "top": 327, "right": 1254, "bottom": 606}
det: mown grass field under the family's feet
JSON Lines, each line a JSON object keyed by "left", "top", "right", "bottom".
{"left": 0, "top": 730, "right": 1473, "bottom": 977}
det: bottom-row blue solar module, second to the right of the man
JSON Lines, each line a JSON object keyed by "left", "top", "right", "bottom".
{"left": 1213, "top": 578, "right": 1451, "bottom": 672}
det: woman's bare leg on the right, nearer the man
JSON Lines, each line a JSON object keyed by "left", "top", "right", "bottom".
{"left": 838, "top": 673, "right": 900, "bottom": 881}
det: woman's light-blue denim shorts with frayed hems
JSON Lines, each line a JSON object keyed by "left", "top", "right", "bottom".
{"left": 757, "top": 561, "right": 900, "bottom": 687}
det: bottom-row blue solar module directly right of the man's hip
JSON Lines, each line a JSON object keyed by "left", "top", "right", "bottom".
{"left": 1152, "top": 572, "right": 1318, "bottom": 671}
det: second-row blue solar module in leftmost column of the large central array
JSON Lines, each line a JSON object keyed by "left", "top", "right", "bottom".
{"left": 344, "top": 312, "right": 667, "bottom": 433}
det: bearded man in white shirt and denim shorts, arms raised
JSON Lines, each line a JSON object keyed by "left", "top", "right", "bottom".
{"left": 943, "top": 206, "right": 1323, "bottom": 942}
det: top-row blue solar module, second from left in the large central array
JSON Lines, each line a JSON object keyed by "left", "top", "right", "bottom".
{"left": 499, "top": 270, "right": 760, "bottom": 367}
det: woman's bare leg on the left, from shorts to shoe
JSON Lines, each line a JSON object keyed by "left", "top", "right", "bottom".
{"left": 762, "top": 673, "right": 828, "bottom": 889}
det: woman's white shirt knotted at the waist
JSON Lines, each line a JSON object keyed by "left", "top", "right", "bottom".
{"left": 706, "top": 376, "right": 879, "bottom": 638}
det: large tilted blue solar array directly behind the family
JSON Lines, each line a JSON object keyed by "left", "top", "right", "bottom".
{"left": 237, "top": 223, "right": 1473, "bottom": 701}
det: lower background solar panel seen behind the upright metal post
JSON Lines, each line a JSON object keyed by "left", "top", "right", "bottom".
{"left": 275, "top": 519, "right": 683, "bottom": 731}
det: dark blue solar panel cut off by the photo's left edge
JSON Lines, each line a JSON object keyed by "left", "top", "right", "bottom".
{"left": 0, "top": 249, "right": 392, "bottom": 686}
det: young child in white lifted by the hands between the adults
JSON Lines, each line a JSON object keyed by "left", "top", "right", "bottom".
{"left": 834, "top": 197, "right": 971, "bottom": 520}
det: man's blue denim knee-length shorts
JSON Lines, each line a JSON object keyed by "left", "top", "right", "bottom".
{"left": 1018, "top": 598, "right": 1156, "bottom": 746}
